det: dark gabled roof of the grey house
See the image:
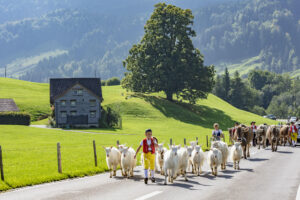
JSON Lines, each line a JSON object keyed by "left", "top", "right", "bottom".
{"left": 50, "top": 78, "right": 102, "bottom": 104}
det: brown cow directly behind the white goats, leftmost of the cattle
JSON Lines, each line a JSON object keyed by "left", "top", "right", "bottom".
{"left": 234, "top": 125, "right": 253, "bottom": 159}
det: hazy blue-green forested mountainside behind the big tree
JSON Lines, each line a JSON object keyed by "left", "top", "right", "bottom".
{"left": 0, "top": 0, "right": 300, "bottom": 82}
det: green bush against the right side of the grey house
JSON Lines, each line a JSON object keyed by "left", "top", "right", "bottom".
{"left": 99, "top": 106, "right": 122, "bottom": 128}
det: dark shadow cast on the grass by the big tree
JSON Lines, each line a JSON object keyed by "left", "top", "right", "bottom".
{"left": 134, "top": 94, "right": 234, "bottom": 128}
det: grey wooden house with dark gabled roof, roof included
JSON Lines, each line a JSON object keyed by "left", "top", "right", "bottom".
{"left": 50, "top": 78, "right": 102, "bottom": 127}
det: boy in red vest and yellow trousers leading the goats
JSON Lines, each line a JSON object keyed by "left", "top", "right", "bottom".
{"left": 134, "top": 129, "right": 158, "bottom": 184}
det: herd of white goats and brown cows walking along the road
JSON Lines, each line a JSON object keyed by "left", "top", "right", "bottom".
{"left": 105, "top": 125, "right": 290, "bottom": 184}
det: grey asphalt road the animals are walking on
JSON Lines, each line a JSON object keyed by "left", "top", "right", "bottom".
{"left": 0, "top": 147, "right": 300, "bottom": 200}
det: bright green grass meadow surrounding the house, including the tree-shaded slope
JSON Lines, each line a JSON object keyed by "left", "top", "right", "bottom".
{"left": 0, "top": 79, "right": 273, "bottom": 190}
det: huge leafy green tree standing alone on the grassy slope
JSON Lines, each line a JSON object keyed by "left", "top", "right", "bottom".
{"left": 122, "top": 3, "right": 215, "bottom": 103}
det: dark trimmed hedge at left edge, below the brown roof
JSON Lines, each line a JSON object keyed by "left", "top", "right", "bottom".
{"left": 0, "top": 112, "right": 30, "bottom": 125}
